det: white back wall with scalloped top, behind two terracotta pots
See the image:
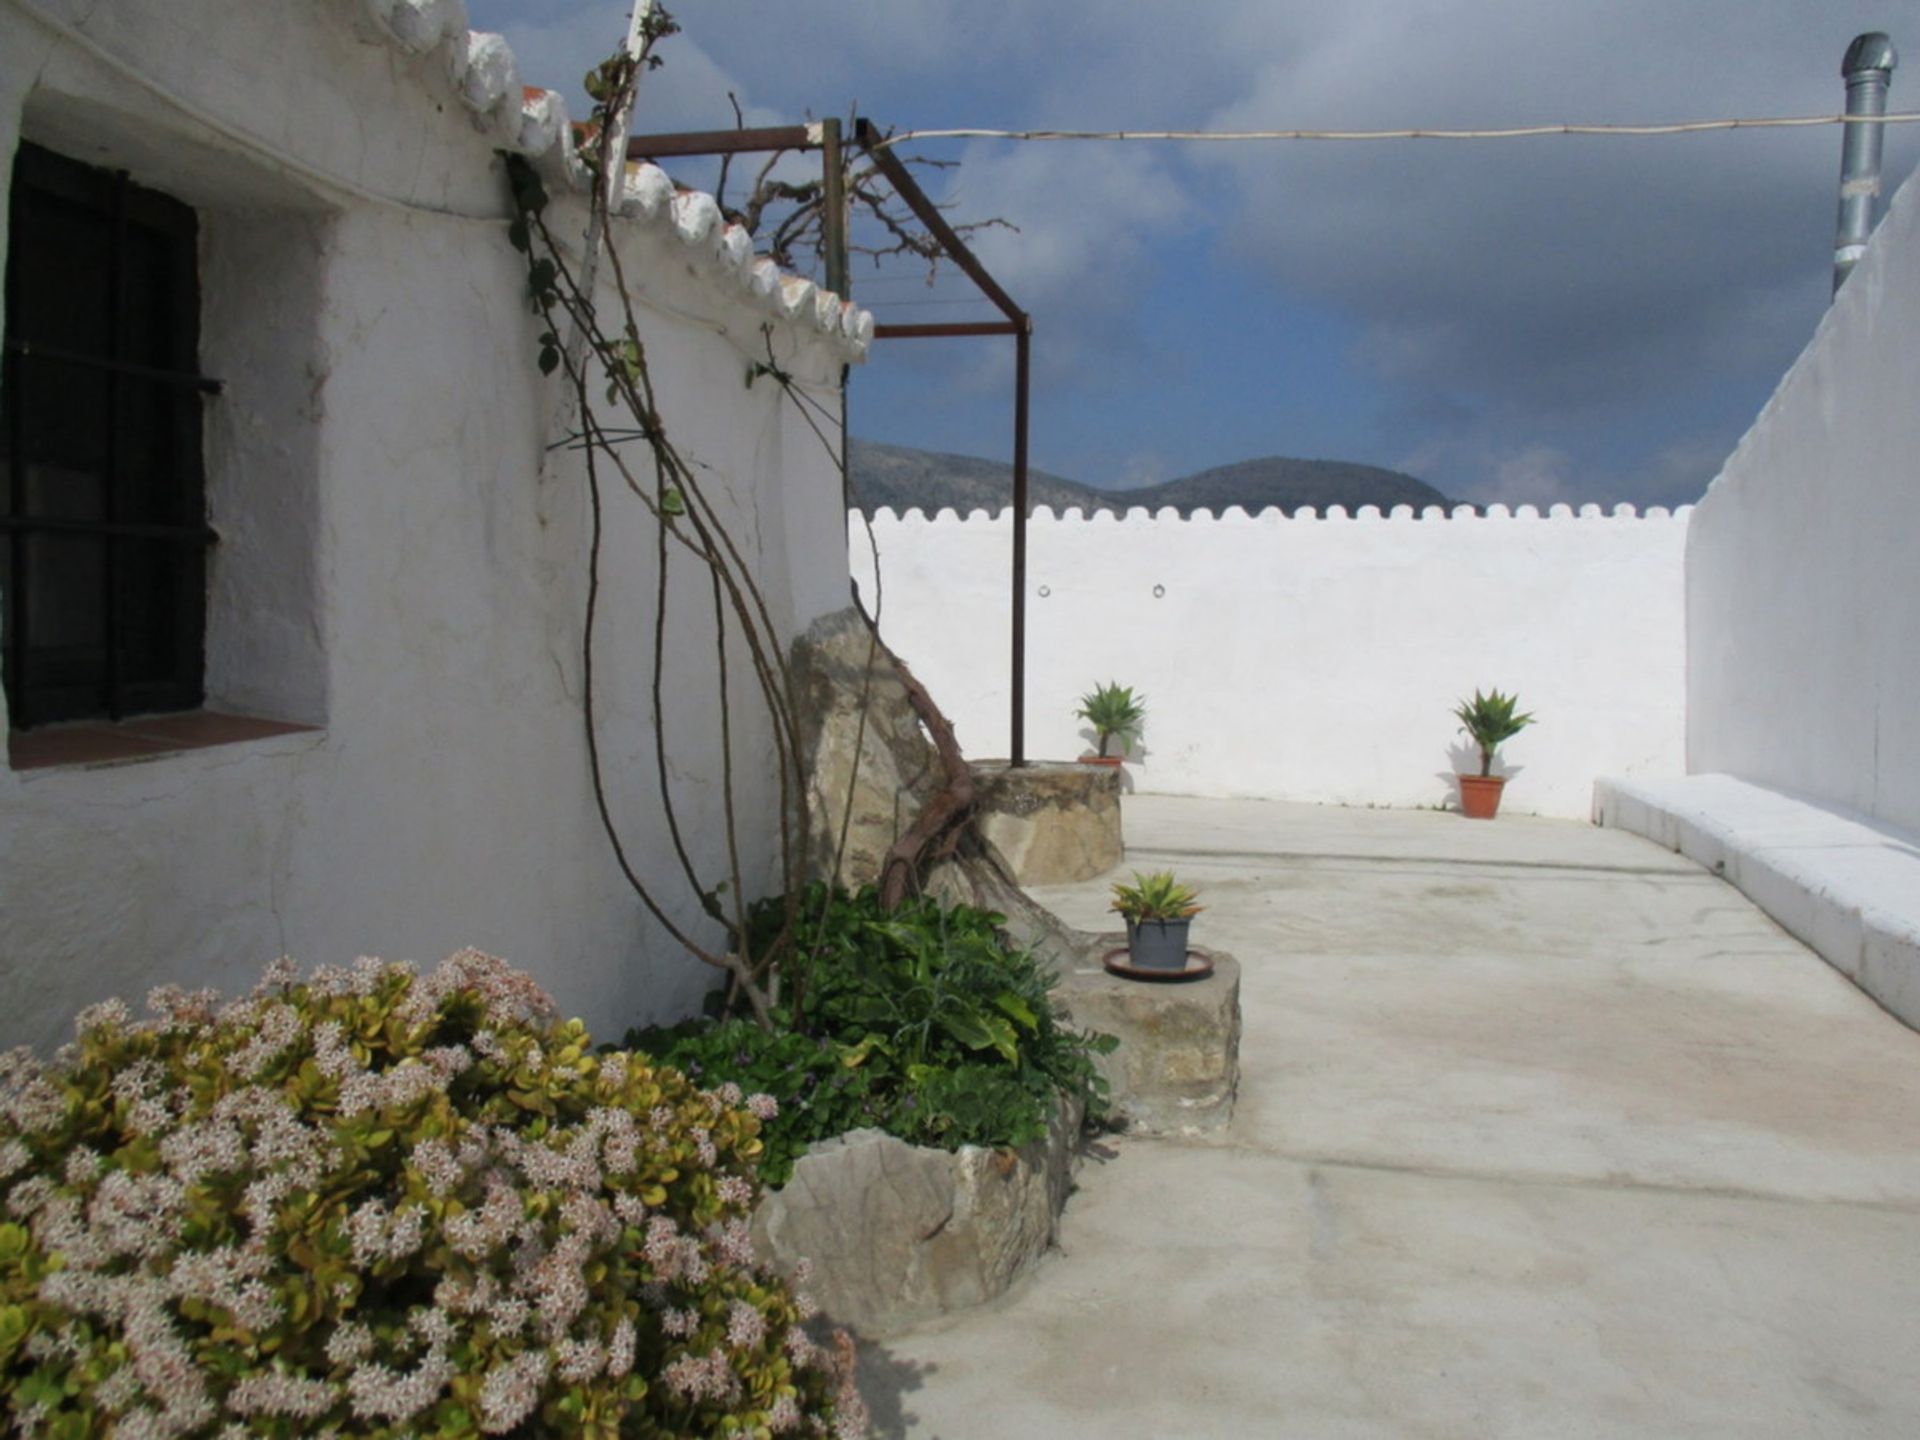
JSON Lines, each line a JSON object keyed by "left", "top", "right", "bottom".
{"left": 849, "top": 505, "right": 1688, "bottom": 818}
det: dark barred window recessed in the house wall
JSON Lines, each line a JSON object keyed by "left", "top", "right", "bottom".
{"left": 0, "top": 144, "right": 221, "bottom": 730}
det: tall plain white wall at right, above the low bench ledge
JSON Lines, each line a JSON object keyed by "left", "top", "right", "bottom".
{"left": 1688, "top": 166, "right": 1920, "bottom": 829}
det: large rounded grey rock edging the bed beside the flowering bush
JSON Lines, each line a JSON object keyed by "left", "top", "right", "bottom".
{"left": 753, "top": 1108, "right": 1081, "bottom": 1336}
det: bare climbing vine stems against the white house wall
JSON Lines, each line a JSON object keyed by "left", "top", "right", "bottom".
{"left": 505, "top": 10, "right": 996, "bottom": 1029}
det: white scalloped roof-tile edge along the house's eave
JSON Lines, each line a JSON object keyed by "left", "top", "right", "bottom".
{"left": 359, "top": 0, "right": 874, "bottom": 361}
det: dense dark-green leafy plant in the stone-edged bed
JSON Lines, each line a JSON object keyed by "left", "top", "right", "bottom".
{"left": 628, "top": 885, "right": 1114, "bottom": 1185}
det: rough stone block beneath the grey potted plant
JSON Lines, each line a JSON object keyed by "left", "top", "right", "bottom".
{"left": 1052, "top": 948, "right": 1240, "bottom": 1135}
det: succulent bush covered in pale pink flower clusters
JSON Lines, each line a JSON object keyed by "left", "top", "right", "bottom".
{"left": 0, "top": 950, "right": 866, "bottom": 1440}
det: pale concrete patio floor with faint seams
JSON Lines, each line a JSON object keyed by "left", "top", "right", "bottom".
{"left": 862, "top": 797, "right": 1920, "bottom": 1440}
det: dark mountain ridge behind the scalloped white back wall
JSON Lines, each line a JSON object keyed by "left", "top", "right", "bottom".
{"left": 849, "top": 438, "right": 1453, "bottom": 516}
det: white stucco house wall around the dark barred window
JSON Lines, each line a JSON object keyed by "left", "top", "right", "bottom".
{"left": 0, "top": 0, "right": 858, "bottom": 1044}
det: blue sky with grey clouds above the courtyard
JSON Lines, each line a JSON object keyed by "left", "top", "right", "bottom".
{"left": 468, "top": 0, "right": 1920, "bottom": 503}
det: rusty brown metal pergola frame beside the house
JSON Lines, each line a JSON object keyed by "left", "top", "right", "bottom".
{"left": 626, "top": 117, "right": 1033, "bottom": 766}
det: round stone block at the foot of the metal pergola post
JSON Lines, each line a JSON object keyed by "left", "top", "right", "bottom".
{"left": 973, "top": 760, "right": 1123, "bottom": 885}
